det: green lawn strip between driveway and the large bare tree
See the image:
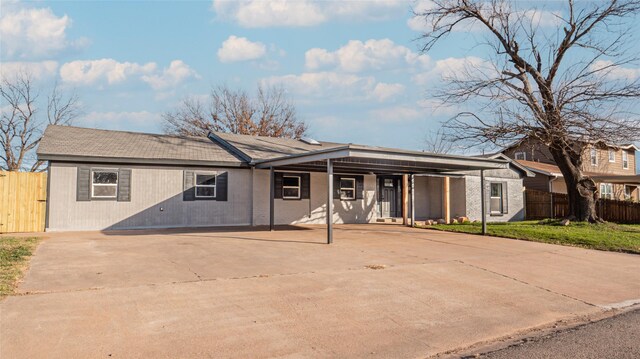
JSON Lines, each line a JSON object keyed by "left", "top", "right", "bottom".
{"left": 425, "top": 221, "right": 640, "bottom": 254}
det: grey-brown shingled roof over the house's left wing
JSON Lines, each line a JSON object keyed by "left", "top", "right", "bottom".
{"left": 37, "top": 125, "right": 246, "bottom": 166}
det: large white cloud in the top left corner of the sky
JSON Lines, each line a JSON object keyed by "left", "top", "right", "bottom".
{"left": 0, "top": 6, "right": 88, "bottom": 59}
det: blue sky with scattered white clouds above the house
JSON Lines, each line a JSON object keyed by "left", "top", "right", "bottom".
{"left": 0, "top": 0, "right": 640, "bottom": 165}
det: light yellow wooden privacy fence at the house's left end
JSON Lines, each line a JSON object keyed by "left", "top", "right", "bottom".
{"left": 0, "top": 171, "right": 47, "bottom": 233}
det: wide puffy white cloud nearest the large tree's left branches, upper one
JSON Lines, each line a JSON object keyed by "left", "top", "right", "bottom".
{"left": 305, "top": 39, "right": 429, "bottom": 72}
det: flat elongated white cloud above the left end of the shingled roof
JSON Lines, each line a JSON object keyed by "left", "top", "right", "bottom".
{"left": 60, "top": 59, "right": 157, "bottom": 85}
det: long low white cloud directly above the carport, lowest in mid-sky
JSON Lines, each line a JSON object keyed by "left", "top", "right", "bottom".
{"left": 262, "top": 72, "right": 404, "bottom": 101}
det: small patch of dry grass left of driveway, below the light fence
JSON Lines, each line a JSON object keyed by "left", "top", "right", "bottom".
{"left": 0, "top": 237, "right": 40, "bottom": 299}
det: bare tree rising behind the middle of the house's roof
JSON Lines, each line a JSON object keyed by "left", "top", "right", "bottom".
{"left": 162, "top": 86, "right": 307, "bottom": 138}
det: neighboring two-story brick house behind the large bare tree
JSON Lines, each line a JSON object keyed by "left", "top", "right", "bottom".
{"left": 502, "top": 139, "right": 640, "bottom": 202}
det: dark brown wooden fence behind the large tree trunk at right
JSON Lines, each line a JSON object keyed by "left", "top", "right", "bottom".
{"left": 525, "top": 189, "right": 640, "bottom": 223}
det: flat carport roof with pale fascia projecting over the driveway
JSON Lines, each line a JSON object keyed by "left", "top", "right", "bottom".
{"left": 255, "top": 144, "right": 509, "bottom": 174}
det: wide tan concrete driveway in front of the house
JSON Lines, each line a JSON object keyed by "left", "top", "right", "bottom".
{"left": 0, "top": 225, "right": 640, "bottom": 358}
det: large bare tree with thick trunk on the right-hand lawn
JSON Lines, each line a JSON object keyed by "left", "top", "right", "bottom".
{"left": 416, "top": 0, "right": 640, "bottom": 222}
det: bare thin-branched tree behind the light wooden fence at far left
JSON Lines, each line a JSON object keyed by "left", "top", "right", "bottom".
{"left": 0, "top": 71, "right": 80, "bottom": 172}
